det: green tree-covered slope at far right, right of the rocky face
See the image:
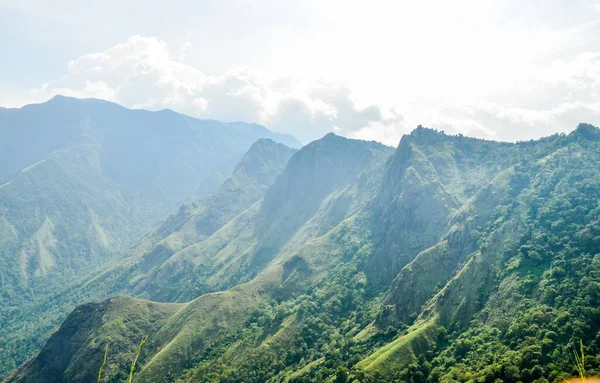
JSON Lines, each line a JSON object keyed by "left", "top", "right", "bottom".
{"left": 359, "top": 125, "right": 600, "bottom": 382}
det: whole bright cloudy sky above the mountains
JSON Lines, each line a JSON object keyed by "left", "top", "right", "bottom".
{"left": 0, "top": 0, "right": 600, "bottom": 145}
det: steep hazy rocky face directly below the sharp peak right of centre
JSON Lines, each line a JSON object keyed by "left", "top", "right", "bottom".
{"left": 366, "top": 127, "right": 524, "bottom": 289}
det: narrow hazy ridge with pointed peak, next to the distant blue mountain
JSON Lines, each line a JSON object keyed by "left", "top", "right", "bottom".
{"left": 79, "top": 139, "right": 296, "bottom": 302}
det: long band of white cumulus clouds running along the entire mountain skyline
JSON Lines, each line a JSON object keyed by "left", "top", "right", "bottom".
{"left": 25, "top": 36, "right": 600, "bottom": 145}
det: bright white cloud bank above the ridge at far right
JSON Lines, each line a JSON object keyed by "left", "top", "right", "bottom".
{"left": 412, "top": 48, "right": 600, "bottom": 141}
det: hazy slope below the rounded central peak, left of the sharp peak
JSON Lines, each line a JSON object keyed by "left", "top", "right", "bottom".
{"left": 127, "top": 135, "right": 390, "bottom": 301}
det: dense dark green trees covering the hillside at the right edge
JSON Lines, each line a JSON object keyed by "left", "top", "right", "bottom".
{"left": 420, "top": 135, "right": 600, "bottom": 383}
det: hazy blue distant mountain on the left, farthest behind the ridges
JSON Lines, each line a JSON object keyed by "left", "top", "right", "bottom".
{"left": 0, "top": 96, "right": 300, "bottom": 375}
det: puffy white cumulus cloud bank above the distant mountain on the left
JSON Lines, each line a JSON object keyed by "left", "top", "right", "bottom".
{"left": 33, "top": 36, "right": 402, "bottom": 142}
